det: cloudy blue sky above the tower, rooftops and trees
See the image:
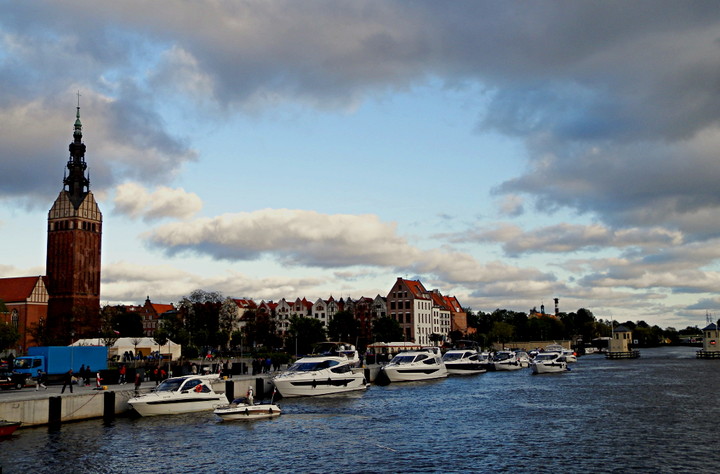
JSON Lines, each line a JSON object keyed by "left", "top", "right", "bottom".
{"left": 0, "top": 0, "right": 720, "bottom": 329}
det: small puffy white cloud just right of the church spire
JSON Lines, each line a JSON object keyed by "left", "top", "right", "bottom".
{"left": 114, "top": 182, "right": 202, "bottom": 222}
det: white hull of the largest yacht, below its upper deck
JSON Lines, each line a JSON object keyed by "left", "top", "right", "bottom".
{"left": 273, "top": 372, "right": 368, "bottom": 398}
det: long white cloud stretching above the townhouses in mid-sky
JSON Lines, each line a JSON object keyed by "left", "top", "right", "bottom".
{"left": 146, "top": 209, "right": 419, "bottom": 267}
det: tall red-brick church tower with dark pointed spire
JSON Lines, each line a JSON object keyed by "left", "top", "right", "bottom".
{"left": 47, "top": 103, "right": 102, "bottom": 344}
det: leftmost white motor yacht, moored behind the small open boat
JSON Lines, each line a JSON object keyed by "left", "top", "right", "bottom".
{"left": 128, "top": 374, "right": 227, "bottom": 416}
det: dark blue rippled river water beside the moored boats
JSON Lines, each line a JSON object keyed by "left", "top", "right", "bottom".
{"left": 0, "top": 348, "right": 720, "bottom": 473}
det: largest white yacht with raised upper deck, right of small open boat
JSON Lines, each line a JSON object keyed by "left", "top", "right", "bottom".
{"left": 273, "top": 355, "right": 368, "bottom": 397}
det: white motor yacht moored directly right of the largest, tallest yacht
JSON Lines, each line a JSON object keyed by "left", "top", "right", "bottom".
{"left": 380, "top": 347, "right": 448, "bottom": 382}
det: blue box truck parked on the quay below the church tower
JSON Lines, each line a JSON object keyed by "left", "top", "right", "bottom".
{"left": 14, "top": 346, "right": 107, "bottom": 378}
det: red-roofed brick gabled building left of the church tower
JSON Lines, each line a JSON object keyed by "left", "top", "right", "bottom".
{"left": 0, "top": 276, "right": 48, "bottom": 354}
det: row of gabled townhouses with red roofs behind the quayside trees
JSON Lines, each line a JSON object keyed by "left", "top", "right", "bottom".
{"left": 228, "top": 278, "right": 472, "bottom": 345}
